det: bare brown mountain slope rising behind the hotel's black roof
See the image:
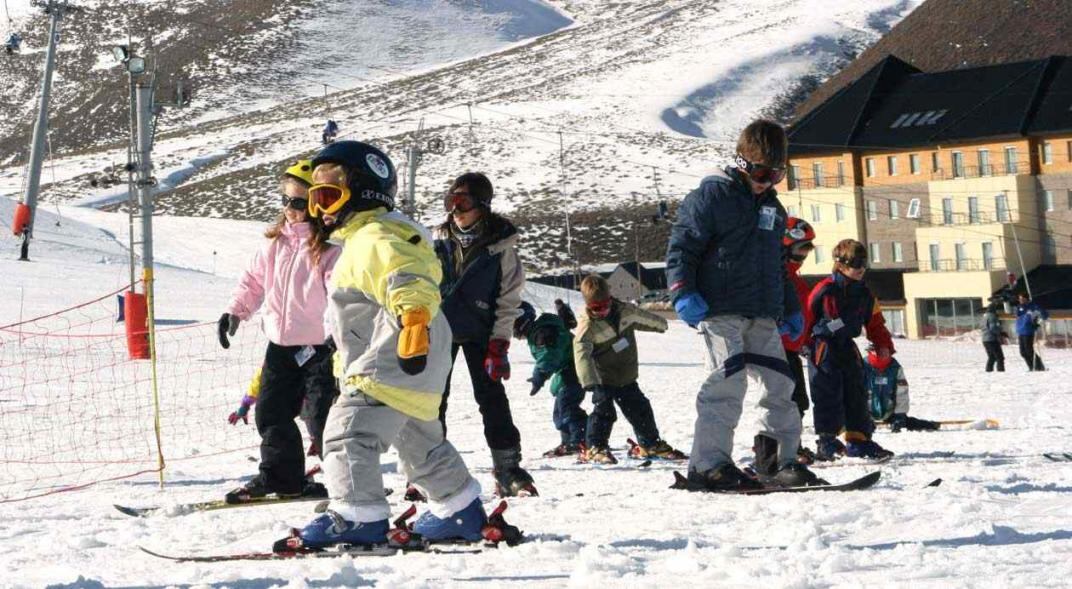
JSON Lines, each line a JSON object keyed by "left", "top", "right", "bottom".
{"left": 796, "top": 0, "right": 1072, "bottom": 120}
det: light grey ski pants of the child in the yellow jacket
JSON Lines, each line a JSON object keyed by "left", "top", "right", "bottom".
{"left": 324, "top": 391, "right": 480, "bottom": 521}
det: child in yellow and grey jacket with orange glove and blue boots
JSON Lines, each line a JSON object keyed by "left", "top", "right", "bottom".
{"left": 293, "top": 141, "right": 488, "bottom": 548}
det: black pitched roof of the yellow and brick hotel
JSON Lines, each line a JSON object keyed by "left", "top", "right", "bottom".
{"left": 789, "top": 56, "right": 1072, "bottom": 154}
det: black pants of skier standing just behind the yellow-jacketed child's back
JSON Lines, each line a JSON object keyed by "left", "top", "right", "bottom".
{"left": 440, "top": 341, "right": 521, "bottom": 450}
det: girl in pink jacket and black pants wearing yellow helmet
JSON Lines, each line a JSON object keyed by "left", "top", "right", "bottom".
{"left": 218, "top": 160, "right": 340, "bottom": 503}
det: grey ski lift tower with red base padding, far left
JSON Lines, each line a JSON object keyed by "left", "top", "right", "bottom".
{"left": 14, "top": 0, "right": 77, "bottom": 262}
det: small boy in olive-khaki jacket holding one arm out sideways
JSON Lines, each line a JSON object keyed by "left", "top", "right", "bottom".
{"left": 574, "top": 275, "right": 687, "bottom": 465}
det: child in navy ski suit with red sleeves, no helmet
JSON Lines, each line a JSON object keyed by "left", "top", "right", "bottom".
{"left": 805, "top": 239, "right": 895, "bottom": 460}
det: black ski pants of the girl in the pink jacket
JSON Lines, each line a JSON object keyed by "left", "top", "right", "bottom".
{"left": 255, "top": 342, "right": 338, "bottom": 494}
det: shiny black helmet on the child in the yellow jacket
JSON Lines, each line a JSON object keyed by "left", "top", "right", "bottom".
{"left": 313, "top": 141, "right": 399, "bottom": 212}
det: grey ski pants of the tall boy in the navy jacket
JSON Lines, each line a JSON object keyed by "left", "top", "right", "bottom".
{"left": 688, "top": 315, "right": 801, "bottom": 472}
